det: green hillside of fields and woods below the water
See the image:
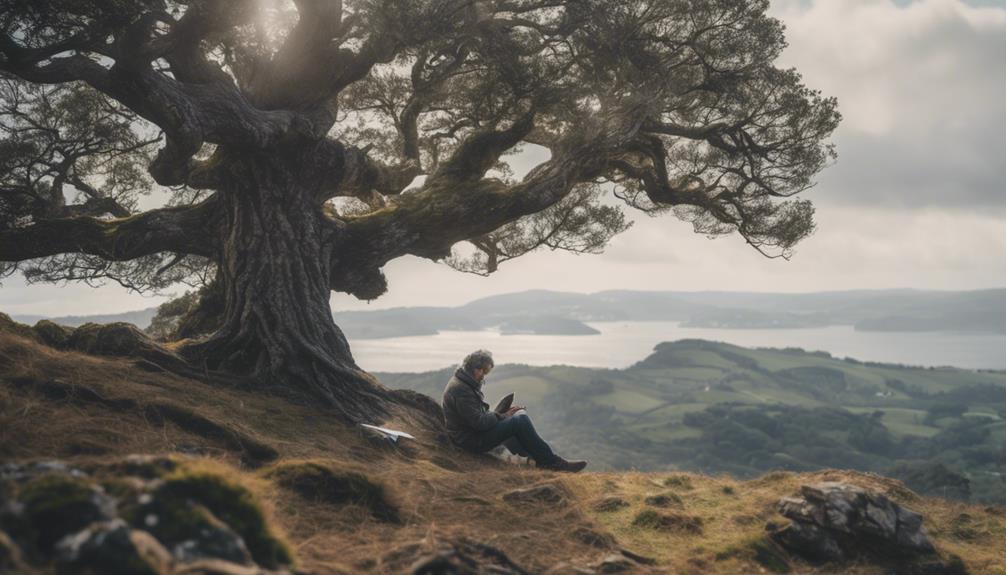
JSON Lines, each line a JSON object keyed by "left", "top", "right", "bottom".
{"left": 380, "top": 340, "right": 1006, "bottom": 505}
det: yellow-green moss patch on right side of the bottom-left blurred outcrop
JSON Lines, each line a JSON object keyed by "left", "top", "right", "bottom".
{"left": 150, "top": 467, "right": 294, "bottom": 569}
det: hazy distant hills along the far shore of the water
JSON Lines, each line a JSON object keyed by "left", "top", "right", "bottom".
{"left": 13, "top": 290, "right": 1006, "bottom": 340}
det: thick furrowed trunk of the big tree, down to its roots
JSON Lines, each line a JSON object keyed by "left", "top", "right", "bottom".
{"left": 185, "top": 151, "right": 389, "bottom": 421}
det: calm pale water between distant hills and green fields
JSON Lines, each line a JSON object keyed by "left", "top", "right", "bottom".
{"left": 350, "top": 322, "right": 1006, "bottom": 372}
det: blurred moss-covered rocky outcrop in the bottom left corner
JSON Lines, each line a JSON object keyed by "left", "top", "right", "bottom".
{"left": 0, "top": 456, "right": 293, "bottom": 575}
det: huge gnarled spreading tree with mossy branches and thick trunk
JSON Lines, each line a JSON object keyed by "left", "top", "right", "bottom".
{"left": 0, "top": 0, "right": 839, "bottom": 418}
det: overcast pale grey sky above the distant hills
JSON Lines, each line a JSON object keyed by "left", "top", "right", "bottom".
{"left": 0, "top": 0, "right": 1006, "bottom": 315}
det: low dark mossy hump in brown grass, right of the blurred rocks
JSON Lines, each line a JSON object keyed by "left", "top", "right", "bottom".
{"left": 266, "top": 461, "right": 400, "bottom": 523}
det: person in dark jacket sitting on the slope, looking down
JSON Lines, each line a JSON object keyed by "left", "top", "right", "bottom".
{"left": 443, "top": 350, "right": 586, "bottom": 472}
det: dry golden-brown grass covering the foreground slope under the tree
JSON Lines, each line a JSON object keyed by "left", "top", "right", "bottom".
{"left": 0, "top": 333, "right": 1006, "bottom": 575}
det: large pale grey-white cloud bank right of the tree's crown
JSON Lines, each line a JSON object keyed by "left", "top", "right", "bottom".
{"left": 773, "top": 0, "right": 1006, "bottom": 210}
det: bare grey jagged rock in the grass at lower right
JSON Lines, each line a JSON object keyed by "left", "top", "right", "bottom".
{"left": 768, "top": 482, "right": 959, "bottom": 575}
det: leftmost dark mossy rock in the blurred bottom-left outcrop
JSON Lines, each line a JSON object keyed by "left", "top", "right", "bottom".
{"left": 12, "top": 473, "right": 115, "bottom": 556}
